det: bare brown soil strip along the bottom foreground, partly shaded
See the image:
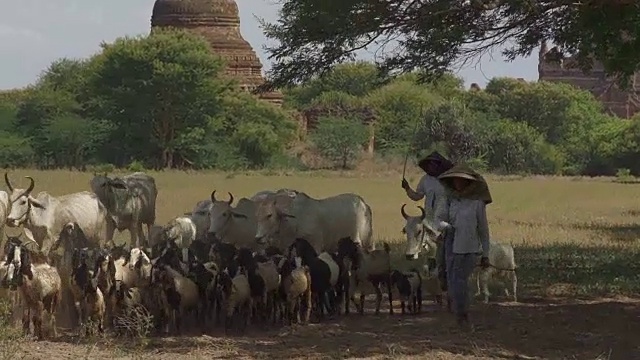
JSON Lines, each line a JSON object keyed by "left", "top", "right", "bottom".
{"left": 13, "top": 298, "right": 640, "bottom": 360}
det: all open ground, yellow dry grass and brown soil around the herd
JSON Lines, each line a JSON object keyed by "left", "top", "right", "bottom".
{"left": 0, "top": 170, "right": 640, "bottom": 359}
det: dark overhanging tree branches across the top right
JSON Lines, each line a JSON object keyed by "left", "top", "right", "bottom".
{"left": 262, "top": 0, "right": 640, "bottom": 87}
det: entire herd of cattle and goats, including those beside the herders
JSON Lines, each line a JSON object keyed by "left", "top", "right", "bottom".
{"left": 0, "top": 172, "right": 517, "bottom": 338}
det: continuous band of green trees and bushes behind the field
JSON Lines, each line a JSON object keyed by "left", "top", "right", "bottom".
{"left": 0, "top": 30, "right": 640, "bottom": 175}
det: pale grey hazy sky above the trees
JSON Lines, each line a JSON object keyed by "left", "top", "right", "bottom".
{"left": 0, "top": 0, "right": 538, "bottom": 89}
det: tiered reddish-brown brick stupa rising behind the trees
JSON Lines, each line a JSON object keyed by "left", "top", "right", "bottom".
{"left": 151, "top": 0, "right": 282, "bottom": 105}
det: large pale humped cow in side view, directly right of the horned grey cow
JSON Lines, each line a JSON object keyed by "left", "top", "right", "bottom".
{"left": 256, "top": 192, "right": 375, "bottom": 253}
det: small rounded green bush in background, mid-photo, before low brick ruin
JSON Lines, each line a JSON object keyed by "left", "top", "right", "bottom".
{"left": 311, "top": 117, "right": 368, "bottom": 169}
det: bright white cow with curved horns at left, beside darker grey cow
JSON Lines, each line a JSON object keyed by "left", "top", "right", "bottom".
{"left": 4, "top": 173, "right": 107, "bottom": 255}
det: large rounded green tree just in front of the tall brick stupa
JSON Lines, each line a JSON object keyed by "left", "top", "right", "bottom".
{"left": 87, "top": 29, "right": 230, "bottom": 168}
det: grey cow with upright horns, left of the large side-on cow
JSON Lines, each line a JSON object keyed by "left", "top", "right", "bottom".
{"left": 209, "top": 190, "right": 262, "bottom": 251}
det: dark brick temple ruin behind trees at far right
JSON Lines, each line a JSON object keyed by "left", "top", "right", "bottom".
{"left": 538, "top": 43, "right": 640, "bottom": 119}
